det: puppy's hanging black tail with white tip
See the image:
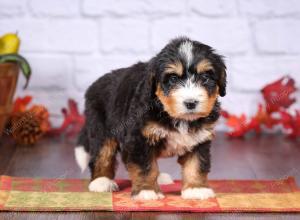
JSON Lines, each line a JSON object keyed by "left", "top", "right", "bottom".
{"left": 74, "top": 127, "right": 90, "bottom": 172}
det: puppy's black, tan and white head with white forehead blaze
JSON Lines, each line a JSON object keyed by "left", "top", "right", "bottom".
{"left": 155, "top": 39, "right": 226, "bottom": 121}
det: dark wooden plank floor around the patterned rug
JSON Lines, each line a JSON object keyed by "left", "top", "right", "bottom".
{"left": 0, "top": 133, "right": 300, "bottom": 220}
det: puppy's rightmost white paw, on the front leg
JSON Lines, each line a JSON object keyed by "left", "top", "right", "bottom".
{"left": 181, "top": 187, "right": 215, "bottom": 200}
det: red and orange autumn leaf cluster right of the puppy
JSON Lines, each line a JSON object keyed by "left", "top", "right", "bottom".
{"left": 222, "top": 76, "right": 300, "bottom": 138}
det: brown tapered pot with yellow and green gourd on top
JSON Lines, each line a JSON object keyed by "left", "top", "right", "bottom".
{"left": 0, "top": 33, "right": 31, "bottom": 136}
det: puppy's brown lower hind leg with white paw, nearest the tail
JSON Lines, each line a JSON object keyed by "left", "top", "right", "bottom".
{"left": 89, "top": 139, "right": 118, "bottom": 192}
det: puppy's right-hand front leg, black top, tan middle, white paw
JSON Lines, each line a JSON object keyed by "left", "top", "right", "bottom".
{"left": 178, "top": 141, "right": 215, "bottom": 200}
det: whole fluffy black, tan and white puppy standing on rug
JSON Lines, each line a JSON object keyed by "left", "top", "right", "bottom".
{"left": 75, "top": 38, "right": 226, "bottom": 200}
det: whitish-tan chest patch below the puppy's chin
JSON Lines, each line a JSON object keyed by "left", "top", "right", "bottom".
{"left": 160, "top": 123, "right": 213, "bottom": 157}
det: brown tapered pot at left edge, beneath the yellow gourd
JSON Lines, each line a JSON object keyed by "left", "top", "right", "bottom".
{"left": 0, "top": 63, "right": 19, "bottom": 136}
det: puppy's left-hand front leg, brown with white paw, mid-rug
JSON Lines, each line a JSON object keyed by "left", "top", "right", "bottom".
{"left": 127, "top": 159, "right": 164, "bottom": 200}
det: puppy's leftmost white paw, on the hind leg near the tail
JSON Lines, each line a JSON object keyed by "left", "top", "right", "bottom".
{"left": 89, "top": 176, "right": 119, "bottom": 192}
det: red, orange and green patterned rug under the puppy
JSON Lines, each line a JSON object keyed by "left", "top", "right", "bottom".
{"left": 0, "top": 176, "right": 300, "bottom": 212}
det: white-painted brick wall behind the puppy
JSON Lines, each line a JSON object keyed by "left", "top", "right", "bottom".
{"left": 0, "top": 0, "right": 300, "bottom": 127}
